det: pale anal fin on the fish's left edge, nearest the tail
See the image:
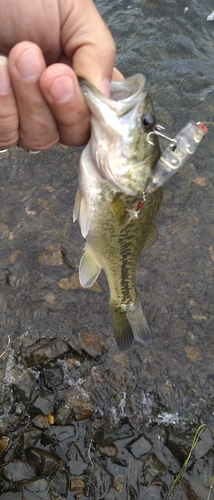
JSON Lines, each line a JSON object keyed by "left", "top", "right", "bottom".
{"left": 79, "top": 244, "right": 102, "bottom": 288}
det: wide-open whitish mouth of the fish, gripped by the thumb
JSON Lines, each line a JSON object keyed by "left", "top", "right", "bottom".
{"left": 79, "top": 74, "right": 147, "bottom": 117}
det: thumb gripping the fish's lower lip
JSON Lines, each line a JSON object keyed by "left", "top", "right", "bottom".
{"left": 60, "top": 0, "right": 116, "bottom": 95}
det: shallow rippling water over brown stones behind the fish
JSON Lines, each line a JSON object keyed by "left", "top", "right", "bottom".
{"left": 0, "top": 0, "right": 214, "bottom": 500}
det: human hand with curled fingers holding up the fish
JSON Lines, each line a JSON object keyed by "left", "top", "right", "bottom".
{"left": 0, "top": 0, "right": 122, "bottom": 150}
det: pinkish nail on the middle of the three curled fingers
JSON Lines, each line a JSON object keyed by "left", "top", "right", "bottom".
{"left": 16, "top": 49, "right": 42, "bottom": 82}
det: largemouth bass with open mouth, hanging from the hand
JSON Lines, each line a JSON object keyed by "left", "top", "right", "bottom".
{"left": 73, "top": 74, "right": 162, "bottom": 349}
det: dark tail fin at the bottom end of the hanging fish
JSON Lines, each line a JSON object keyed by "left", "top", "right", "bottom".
{"left": 111, "top": 301, "right": 150, "bottom": 350}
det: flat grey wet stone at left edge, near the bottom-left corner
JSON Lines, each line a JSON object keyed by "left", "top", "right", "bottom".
{"left": 2, "top": 460, "right": 36, "bottom": 483}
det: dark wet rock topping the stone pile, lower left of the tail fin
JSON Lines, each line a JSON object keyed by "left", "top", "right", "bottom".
{"left": 22, "top": 340, "right": 69, "bottom": 366}
